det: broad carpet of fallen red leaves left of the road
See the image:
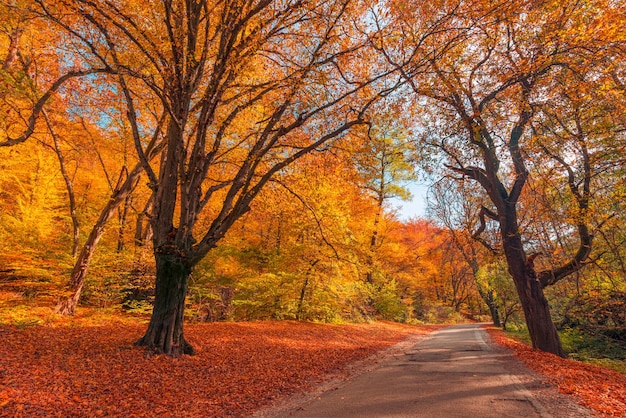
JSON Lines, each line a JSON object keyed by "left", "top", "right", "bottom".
{"left": 0, "top": 322, "right": 434, "bottom": 417}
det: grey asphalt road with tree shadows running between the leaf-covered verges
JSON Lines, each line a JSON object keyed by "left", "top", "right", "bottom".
{"left": 266, "top": 324, "right": 587, "bottom": 418}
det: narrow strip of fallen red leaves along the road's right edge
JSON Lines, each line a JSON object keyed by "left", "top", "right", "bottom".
{"left": 488, "top": 328, "right": 626, "bottom": 417}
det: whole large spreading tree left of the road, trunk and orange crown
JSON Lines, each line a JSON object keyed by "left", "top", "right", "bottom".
{"left": 20, "top": 1, "right": 404, "bottom": 355}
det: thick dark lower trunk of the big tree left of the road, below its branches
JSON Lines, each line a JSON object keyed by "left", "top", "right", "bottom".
{"left": 135, "top": 250, "right": 195, "bottom": 357}
